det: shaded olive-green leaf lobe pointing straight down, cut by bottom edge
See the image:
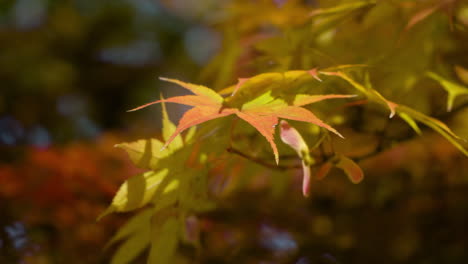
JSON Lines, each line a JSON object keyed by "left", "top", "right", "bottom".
{"left": 148, "top": 215, "right": 180, "bottom": 264}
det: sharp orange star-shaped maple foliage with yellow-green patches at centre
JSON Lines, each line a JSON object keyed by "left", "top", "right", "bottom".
{"left": 129, "top": 78, "right": 354, "bottom": 163}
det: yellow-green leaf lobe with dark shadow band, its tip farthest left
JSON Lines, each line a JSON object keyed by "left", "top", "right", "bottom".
{"left": 98, "top": 169, "right": 179, "bottom": 220}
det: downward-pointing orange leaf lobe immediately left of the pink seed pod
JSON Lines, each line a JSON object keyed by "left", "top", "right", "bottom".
{"left": 236, "top": 112, "right": 279, "bottom": 164}
